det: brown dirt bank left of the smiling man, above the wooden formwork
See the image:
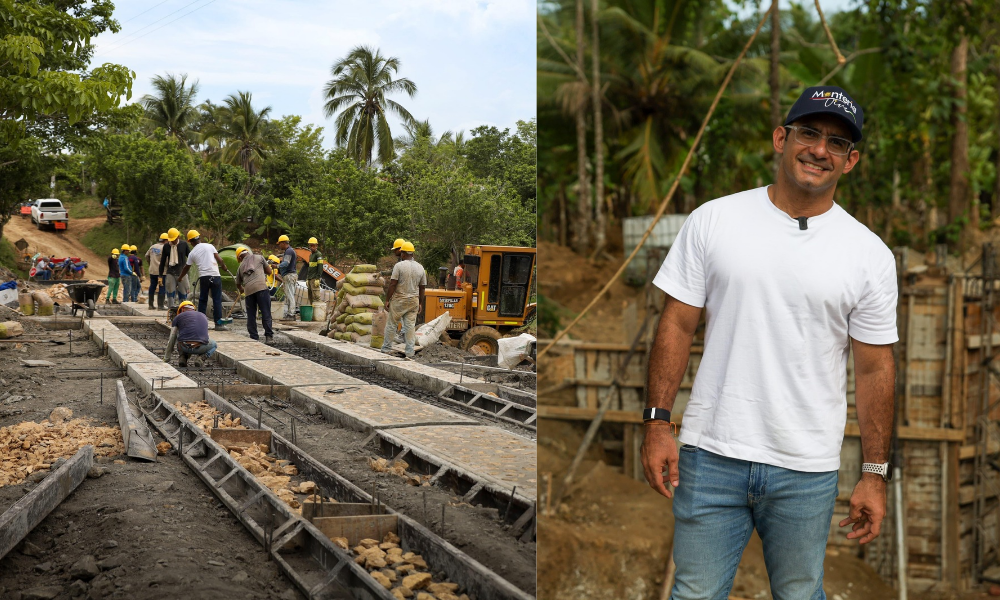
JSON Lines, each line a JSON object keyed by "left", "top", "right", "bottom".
{"left": 538, "top": 240, "right": 643, "bottom": 343}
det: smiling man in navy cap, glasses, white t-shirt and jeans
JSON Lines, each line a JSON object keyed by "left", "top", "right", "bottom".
{"left": 642, "top": 86, "right": 897, "bottom": 600}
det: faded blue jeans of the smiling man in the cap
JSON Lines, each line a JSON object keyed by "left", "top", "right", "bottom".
{"left": 670, "top": 445, "right": 837, "bottom": 600}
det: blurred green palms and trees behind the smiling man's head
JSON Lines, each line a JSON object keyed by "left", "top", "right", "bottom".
{"left": 538, "top": 0, "right": 1000, "bottom": 255}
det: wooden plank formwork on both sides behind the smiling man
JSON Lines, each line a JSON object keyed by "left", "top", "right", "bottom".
{"left": 538, "top": 258, "right": 1000, "bottom": 590}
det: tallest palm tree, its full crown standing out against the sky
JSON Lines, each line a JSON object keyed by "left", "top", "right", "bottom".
{"left": 323, "top": 46, "right": 417, "bottom": 166}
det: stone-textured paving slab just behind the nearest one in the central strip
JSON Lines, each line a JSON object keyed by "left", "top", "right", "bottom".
{"left": 290, "top": 385, "right": 477, "bottom": 432}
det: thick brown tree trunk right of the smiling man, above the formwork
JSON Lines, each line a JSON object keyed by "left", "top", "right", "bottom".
{"left": 948, "top": 1, "right": 971, "bottom": 246}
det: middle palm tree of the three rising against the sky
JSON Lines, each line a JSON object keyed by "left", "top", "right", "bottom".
{"left": 202, "top": 92, "right": 281, "bottom": 175}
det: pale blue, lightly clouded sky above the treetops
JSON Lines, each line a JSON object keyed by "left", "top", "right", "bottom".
{"left": 91, "top": 0, "right": 536, "bottom": 148}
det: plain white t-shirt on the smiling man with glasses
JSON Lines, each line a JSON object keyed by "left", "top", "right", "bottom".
{"left": 653, "top": 187, "right": 898, "bottom": 472}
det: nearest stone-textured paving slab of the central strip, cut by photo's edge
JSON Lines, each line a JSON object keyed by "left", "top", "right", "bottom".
{"left": 379, "top": 425, "right": 538, "bottom": 501}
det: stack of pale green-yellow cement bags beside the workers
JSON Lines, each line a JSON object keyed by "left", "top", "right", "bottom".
{"left": 327, "top": 265, "right": 385, "bottom": 344}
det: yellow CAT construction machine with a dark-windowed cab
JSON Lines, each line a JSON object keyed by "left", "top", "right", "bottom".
{"left": 423, "top": 246, "right": 536, "bottom": 354}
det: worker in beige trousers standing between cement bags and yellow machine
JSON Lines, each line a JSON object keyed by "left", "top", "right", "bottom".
{"left": 382, "top": 242, "right": 427, "bottom": 358}
